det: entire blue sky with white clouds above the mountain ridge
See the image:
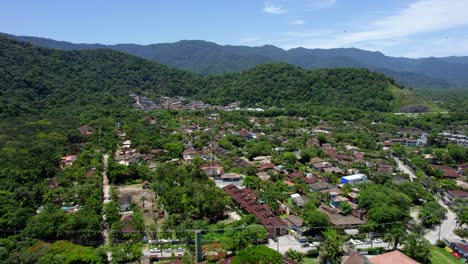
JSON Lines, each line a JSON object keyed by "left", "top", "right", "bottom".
{"left": 0, "top": 0, "right": 468, "bottom": 57}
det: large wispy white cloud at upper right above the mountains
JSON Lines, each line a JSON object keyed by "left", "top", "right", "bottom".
{"left": 281, "top": 0, "right": 468, "bottom": 57}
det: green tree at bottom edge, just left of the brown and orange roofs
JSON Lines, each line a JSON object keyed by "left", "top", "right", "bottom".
{"left": 320, "top": 229, "right": 346, "bottom": 264}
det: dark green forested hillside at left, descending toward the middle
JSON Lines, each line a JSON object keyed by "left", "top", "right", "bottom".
{"left": 0, "top": 37, "right": 203, "bottom": 116}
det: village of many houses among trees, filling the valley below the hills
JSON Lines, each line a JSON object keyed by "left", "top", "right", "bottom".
{"left": 37, "top": 93, "right": 468, "bottom": 264}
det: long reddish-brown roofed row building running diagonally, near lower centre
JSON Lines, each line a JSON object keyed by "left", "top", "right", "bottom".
{"left": 223, "top": 184, "right": 288, "bottom": 238}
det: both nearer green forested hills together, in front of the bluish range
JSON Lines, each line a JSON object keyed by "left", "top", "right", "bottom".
{"left": 0, "top": 34, "right": 416, "bottom": 116}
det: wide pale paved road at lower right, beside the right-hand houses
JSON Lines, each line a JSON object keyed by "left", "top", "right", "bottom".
{"left": 424, "top": 199, "right": 461, "bottom": 244}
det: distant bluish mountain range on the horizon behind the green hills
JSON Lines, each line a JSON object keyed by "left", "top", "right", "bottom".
{"left": 6, "top": 32, "right": 468, "bottom": 89}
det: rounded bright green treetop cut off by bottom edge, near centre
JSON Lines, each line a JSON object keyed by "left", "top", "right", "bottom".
{"left": 232, "top": 246, "right": 283, "bottom": 264}
